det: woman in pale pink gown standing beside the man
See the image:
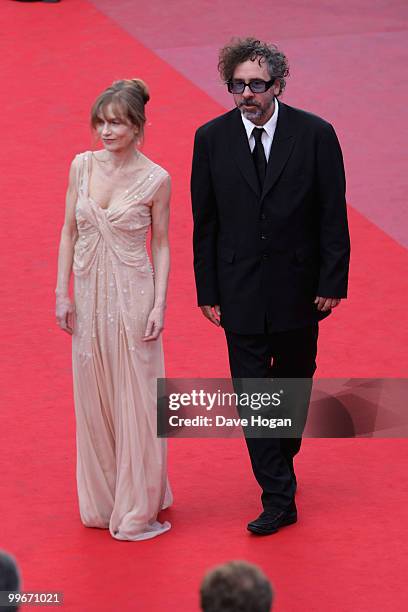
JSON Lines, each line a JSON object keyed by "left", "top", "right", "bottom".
{"left": 56, "top": 79, "right": 172, "bottom": 540}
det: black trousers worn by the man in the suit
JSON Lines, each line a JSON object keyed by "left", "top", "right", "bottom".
{"left": 225, "top": 323, "right": 319, "bottom": 509}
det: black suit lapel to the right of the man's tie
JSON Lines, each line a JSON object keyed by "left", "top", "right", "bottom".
{"left": 261, "top": 102, "right": 296, "bottom": 199}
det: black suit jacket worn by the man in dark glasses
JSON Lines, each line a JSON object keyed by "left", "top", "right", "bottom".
{"left": 191, "top": 102, "right": 350, "bottom": 334}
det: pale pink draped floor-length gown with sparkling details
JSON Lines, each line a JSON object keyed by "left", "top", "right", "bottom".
{"left": 72, "top": 151, "right": 172, "bottom": 540}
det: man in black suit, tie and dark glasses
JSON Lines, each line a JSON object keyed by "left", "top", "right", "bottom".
{"left": 191, "top": 38, "right": 350, "bottom": 534}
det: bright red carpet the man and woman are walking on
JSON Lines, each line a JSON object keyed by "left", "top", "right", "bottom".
{"left": 0, "top": 0, "right": 408, "bottom": 612}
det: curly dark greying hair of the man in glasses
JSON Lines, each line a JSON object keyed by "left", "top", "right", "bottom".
{"left": 218, "top": 37, "right": 289, "bottom": 96}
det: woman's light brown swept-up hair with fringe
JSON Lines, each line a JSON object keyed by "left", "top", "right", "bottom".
{"left": 91, "top": 79, "right": 150, "bottom": 139}
